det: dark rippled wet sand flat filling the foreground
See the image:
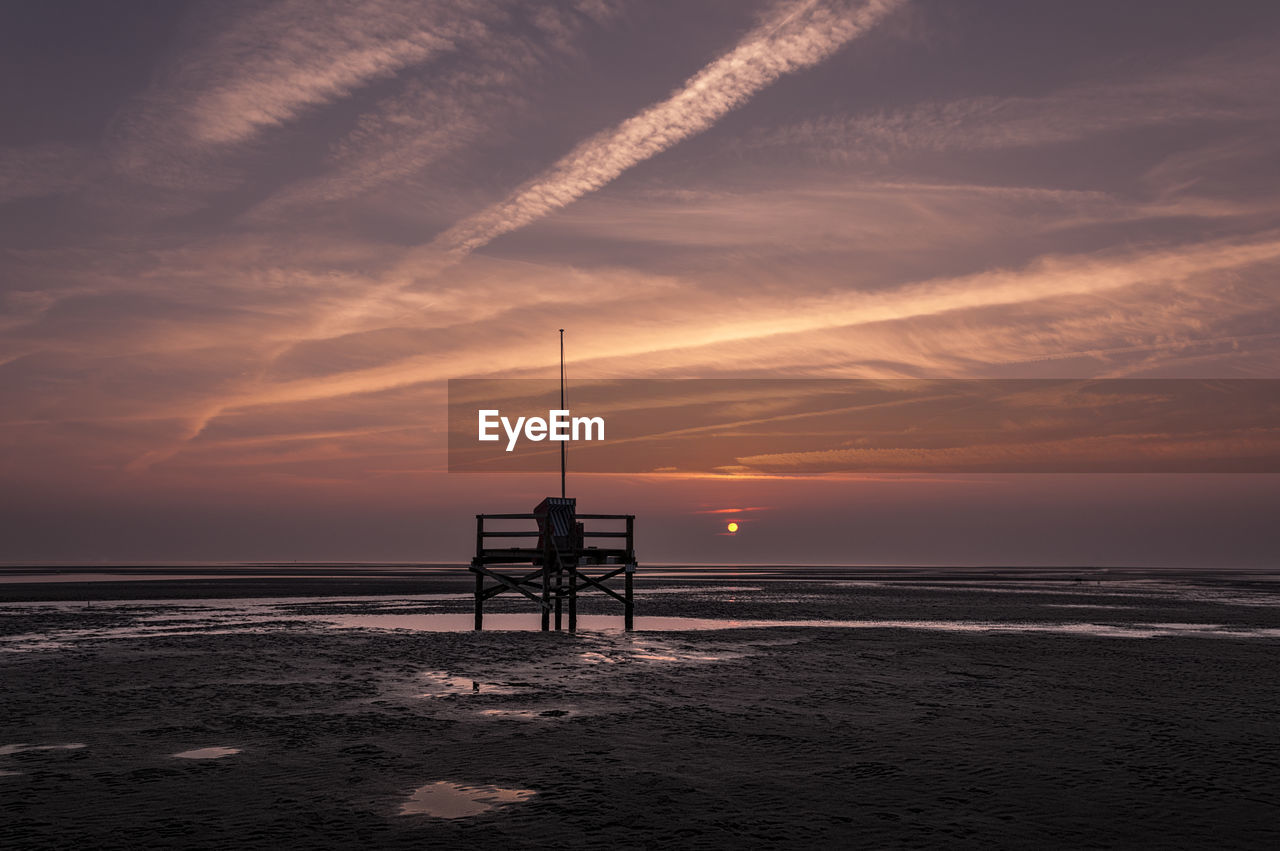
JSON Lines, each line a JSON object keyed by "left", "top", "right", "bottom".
{"left": 0, "top": 570, "right": 1280, "bottom": 848}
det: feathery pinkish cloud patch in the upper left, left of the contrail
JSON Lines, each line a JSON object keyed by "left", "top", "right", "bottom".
{"left": 110, "top": 0, "right": 512, "bottom": 189}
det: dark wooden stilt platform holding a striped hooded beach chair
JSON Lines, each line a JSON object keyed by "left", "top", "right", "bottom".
{"left": 471, "top": 497, "right": 636, "bottom": 632}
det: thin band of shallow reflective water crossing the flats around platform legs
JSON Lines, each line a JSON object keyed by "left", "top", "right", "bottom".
{"left": 0, "top": 580, "right": 1280, "bottom": 650}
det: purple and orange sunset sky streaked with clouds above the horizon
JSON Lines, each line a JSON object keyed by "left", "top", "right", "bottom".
{"left": 0, "top": 0, "right": 1280, "bottom": 567}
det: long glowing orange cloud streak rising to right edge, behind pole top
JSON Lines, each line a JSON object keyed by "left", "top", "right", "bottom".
{"left": 160, "top": 232, "right": 1280, "bottom": 422}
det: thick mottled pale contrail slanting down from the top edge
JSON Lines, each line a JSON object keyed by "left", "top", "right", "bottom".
{"left": 429, "top": 0, "right": 904, "bottom": 258}
